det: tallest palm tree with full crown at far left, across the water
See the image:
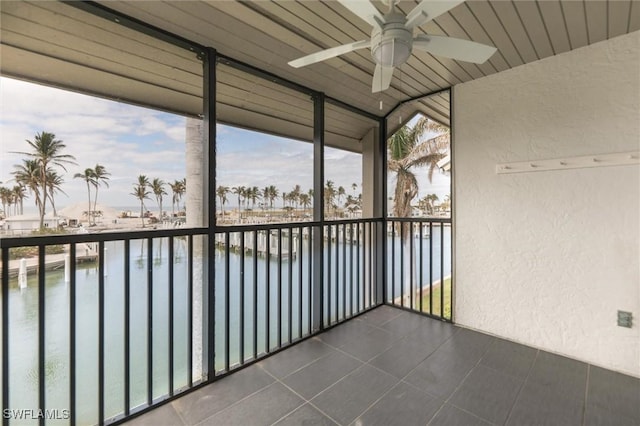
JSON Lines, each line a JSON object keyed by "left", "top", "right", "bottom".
{"left": 18, "top": 131, "right": 76, "bottom": 229}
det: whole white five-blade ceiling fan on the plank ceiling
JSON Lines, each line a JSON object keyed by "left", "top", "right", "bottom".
{"left": 289, "top": 0, "right": 497, "bottom": 93}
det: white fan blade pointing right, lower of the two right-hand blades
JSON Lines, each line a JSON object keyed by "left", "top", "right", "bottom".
{"left": 413, "top": 35, "right": 498, "bottom": 64}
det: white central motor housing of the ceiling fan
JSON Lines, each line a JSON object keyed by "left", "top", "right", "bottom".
{"left": 371, "top": 13, "right": 413, "bottom": 67}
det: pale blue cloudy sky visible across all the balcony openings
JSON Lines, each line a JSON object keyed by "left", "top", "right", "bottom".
{"left": 0, "top": 77, "right": 449, "bottom": 213}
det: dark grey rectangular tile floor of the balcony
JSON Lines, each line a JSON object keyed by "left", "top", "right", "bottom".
{"left": 128, "top": 306, "right": 640, "bottom": 426}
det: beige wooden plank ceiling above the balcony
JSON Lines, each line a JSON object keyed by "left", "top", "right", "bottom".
{"left": 0, "top": 0, "right": 640, "bottom": 146}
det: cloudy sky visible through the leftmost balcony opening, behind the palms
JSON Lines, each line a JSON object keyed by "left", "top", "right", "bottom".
{"left": 0, "top": 77, "right": 186, "bottom": 211}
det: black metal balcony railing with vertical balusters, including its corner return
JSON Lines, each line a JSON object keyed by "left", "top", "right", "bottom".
{"left": 0, "top": 219, "right": 451, "bottom": 424}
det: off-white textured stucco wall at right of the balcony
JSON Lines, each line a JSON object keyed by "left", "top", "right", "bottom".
{"left": 453, "top": 32, "right": 640, "bottom": 376}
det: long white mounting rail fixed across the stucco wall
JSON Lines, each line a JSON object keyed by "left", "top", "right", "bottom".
{"left": 496, "top": 151, "right": 640, "bottom": 174}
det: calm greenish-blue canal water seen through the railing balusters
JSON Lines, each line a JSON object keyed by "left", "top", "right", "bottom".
{"left": 3, "top": 231, "right": 451, "bottom": 424}
